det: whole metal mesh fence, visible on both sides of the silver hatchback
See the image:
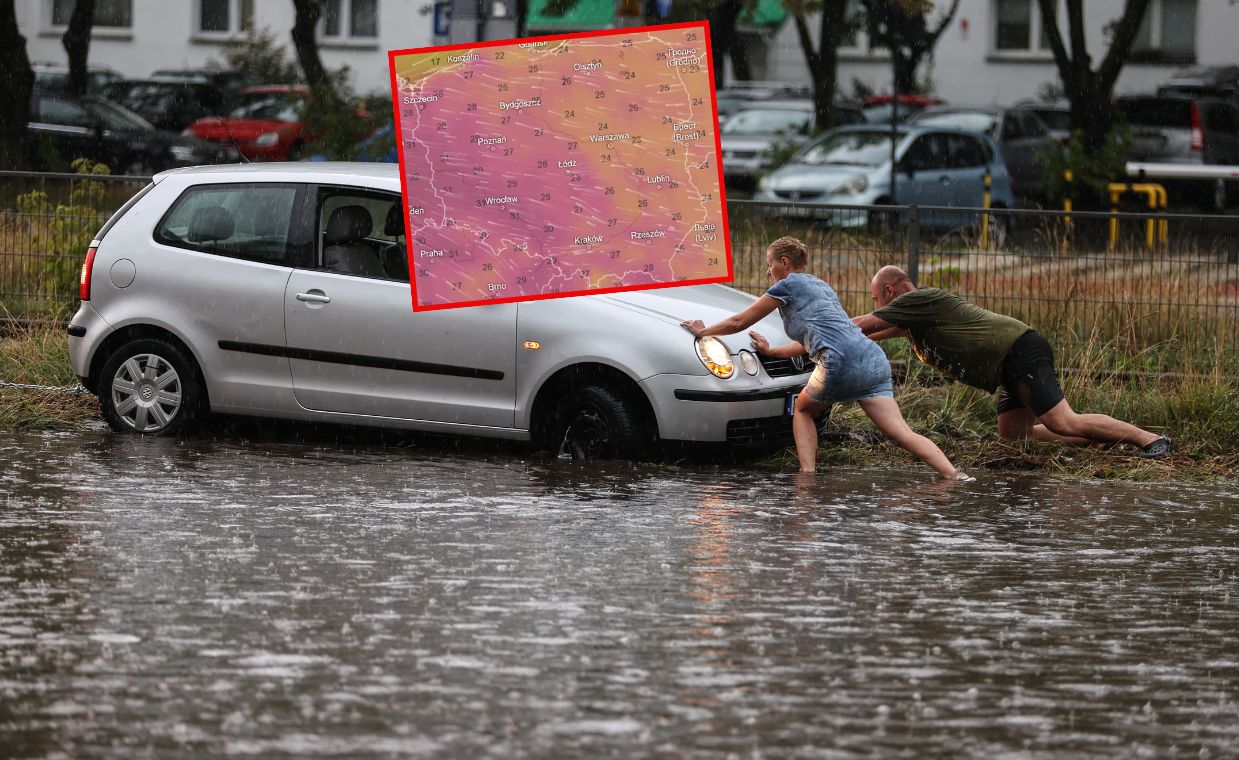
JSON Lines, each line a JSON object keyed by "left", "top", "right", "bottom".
{"left": 0, "top": 172, "right": 1239, "bottom": 369}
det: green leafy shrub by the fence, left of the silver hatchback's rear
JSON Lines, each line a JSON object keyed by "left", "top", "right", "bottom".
{"left": 17, "top": 159, "right": 112, "bottom": 303}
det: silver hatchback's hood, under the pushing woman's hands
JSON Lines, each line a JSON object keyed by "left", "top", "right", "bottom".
{"left": 597, "top": 285, "right": 786, "bottom": 351}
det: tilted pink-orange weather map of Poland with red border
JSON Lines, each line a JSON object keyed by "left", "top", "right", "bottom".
{"left": 389, "top": 22, "right": 731, "bottom": 310}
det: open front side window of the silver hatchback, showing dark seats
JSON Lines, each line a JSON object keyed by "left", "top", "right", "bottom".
{"left": 316, "top": 187, "right": 409, "bottom": 283}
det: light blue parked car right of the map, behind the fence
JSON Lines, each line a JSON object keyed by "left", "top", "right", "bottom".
{"left": 753, "top": 125, "right": 1015, "bottom": 232}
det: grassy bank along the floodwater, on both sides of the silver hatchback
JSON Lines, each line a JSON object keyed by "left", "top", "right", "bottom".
{"left": 0, "top": 322, "right": 1239, "bottom": 480}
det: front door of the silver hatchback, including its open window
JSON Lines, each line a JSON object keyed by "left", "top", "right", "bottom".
{"left": 284, "top": 186, "right": 517, "bottom": 428}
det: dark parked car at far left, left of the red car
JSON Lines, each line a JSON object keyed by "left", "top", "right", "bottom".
{"left": 26, "top": 91, "right": 240, "bottom": 176}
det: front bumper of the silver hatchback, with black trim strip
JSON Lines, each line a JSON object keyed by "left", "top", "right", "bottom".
{"left": 641, "top": 372, "right": 810, "bottom": 446}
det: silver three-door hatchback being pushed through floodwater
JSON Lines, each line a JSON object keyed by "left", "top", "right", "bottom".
{"left": 68, "top": 162, "right": 812, "bottom": 459}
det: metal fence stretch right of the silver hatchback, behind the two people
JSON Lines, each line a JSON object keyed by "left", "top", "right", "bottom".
{"left": 729, "top": 201, "right": 1239, "bottom": 371}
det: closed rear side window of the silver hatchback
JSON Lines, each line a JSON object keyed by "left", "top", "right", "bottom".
{"left": 155, "top": 183, "right": 301, "bottom": 267}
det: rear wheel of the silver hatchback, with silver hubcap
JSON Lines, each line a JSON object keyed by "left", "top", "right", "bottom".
{"left": 98, "top": 338, "right": 204, "bottom": 435}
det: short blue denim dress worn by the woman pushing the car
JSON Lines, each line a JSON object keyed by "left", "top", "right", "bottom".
{"left": 766, "top": 272, "right": 895, "bottom": 404}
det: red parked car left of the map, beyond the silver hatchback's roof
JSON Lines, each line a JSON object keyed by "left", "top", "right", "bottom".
{"left": 185, "top": 84, "right": 310, "bottom": 161}
